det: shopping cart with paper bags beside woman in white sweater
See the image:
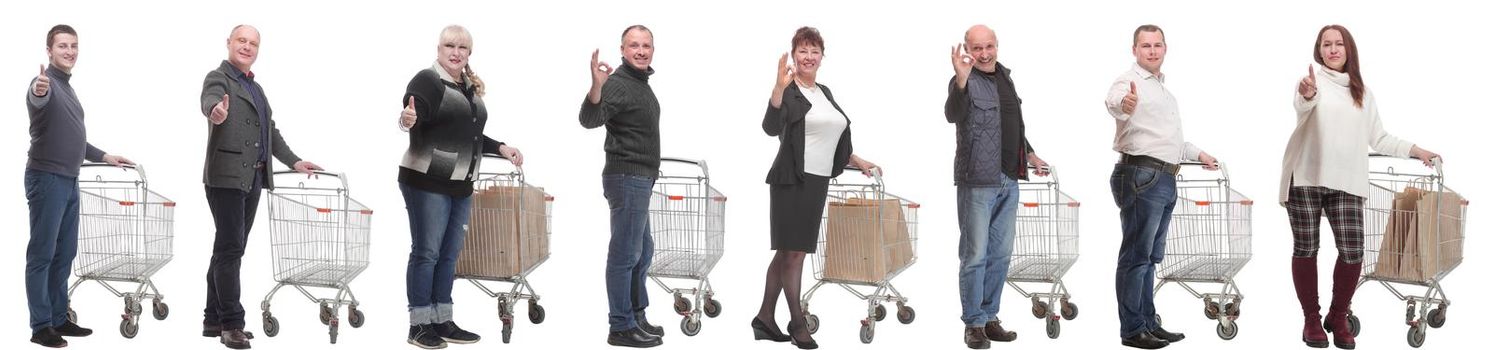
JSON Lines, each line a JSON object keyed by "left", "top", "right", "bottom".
{"left": 1348, "top": 154, "right": 1468, "bottom": 347}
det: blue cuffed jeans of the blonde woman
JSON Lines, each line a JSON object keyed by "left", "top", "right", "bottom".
{"left": 399, "top": 184, "right": 472, "bottom": 326}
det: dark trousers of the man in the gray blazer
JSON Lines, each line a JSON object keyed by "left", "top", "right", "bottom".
{"left": 202, "top": 187, "right": 261, "bottom": 329}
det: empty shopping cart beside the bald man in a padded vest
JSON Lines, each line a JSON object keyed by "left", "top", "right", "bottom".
{"left": 1006, "top": 168, "right": 1078, "bottom": 340}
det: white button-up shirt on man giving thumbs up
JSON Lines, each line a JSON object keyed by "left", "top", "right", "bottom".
{"left": 1105, "top": 64, "right": 1203, "bottom": 165}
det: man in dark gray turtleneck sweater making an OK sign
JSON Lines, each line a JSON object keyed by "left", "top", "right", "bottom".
{"left": 581, "top": 25, "right": 663, "bottom": 347}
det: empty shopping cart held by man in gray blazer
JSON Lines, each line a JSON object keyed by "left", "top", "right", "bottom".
{"left": 260, "top": 171, "right": 373, "bottom": 344}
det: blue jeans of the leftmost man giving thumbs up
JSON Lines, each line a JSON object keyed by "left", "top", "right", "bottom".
{"left": 25, "top": 169, "right": 78, "bottom": 332}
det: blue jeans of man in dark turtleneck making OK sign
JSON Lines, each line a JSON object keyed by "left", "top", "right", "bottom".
{"left": 602, "top": 175, "right": 654, "bottom": 332}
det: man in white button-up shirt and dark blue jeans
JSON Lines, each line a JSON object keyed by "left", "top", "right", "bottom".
{"left": 1105, "top": 24, "right": 1218, "bottom": 349}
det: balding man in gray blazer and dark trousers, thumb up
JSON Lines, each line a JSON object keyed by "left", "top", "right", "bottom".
{"left": 202, "top": 25, "right": 321, "bottom": 349}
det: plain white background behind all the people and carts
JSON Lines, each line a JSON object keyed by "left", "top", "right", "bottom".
{"left": 0, "top": 1, "right": 1493, "bottom": 349}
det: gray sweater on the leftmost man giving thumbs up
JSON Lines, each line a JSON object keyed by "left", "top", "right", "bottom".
{"left": 25, "top": 67, "right": 105, "bottom": 178}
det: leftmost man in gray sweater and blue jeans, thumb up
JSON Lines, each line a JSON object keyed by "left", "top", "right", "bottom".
{"left": 25, "top": 24, "right": 134, "bottom": 347}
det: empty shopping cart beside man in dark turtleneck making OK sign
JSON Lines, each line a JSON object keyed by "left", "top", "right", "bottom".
{"left": 648, "top": 157, "right": 726, "bottom": 337}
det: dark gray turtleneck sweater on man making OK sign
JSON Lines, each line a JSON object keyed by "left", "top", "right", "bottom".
{"left": 581, "top": 63, "right": 660, "bottom": 176}
